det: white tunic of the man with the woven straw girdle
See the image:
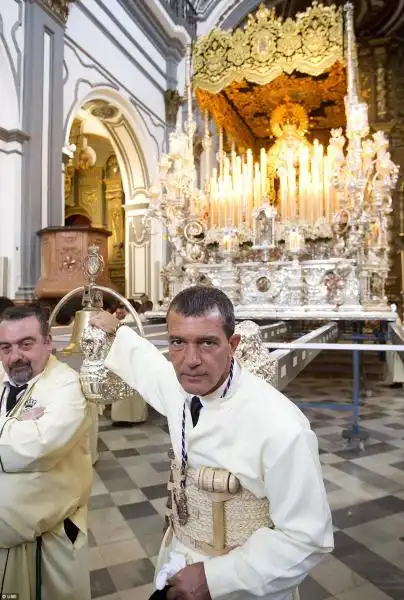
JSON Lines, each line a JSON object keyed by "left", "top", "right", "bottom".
{"left": 106, "top": 327, "right": 333, "bottom": 600}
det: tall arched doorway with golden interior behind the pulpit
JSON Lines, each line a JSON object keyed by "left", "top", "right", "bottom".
{"left": 64, "top": 89, "right": 158, "bottom": 298}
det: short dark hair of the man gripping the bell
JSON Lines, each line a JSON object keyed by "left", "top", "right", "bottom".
{"left": 167, "top": 285, "right": 235, "bottom": 338}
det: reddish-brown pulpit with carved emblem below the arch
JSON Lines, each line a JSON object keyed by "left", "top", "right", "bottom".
{"left": 35, "top": 226, "right": 116, "bottom": 299}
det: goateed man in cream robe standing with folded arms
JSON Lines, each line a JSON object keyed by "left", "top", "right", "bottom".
{"left": 0, "top": 306, "right": 92, "bottom": 600}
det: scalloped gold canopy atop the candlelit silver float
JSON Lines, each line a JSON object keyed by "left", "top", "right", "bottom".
{"left": 192, "top": 2, "right": 347, "bottom": 154}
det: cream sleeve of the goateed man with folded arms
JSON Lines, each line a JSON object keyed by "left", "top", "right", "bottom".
{"left": 0, "top": 374, "right": 90, "bottom": 473}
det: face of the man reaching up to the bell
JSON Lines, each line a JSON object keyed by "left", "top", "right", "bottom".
{"left": 167, "top": 311, "right": 240, "bottom": 396}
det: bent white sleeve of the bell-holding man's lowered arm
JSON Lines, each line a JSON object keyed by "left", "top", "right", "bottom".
{"left": 205, "top": 429, "right": 333, "bottom": 600}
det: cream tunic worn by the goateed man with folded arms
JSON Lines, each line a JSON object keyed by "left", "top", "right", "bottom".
{"left": 0, "top": 356, "right": 92, "bottom": 600}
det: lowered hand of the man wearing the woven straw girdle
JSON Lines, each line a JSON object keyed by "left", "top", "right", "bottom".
{"left": 167, "top": 563, "right": 211, "bottom": 600}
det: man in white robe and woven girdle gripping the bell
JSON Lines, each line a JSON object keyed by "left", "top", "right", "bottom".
{"left": 92, "top": 286, "right": 333, "bottom": 600}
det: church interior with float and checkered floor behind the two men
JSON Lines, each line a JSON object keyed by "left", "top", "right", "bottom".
{"left": 0, "top": 0, "right": 404, "bottom": 600}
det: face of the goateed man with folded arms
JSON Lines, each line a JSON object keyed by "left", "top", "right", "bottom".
{"left": 0, "top": 316, "right": 52, "bottom": 385}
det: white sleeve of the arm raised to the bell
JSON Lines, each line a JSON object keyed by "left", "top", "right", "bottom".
{"left": 105, "top": 327, "right": 178, "bottom": 416}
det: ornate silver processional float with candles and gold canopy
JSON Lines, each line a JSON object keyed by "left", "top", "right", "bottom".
{"left": 146, "top": 2, "right": 398, "bottom": 319}
